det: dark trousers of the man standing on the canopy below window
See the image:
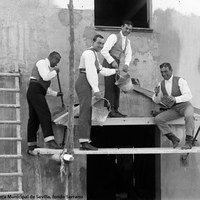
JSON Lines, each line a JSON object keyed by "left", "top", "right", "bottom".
{"left": 102, "top": 59, "right": 120, "bottom": 110}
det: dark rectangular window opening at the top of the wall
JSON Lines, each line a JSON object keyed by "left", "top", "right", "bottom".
{"left": 94, "top": 0, "right": 151, "bottom": 28}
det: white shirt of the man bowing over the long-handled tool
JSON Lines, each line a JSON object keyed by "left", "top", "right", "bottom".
{"left": 30, "top": 58, "right": 58, "bottom": 96}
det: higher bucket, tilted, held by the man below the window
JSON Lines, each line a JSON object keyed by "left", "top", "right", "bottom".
{"left": 115, "top": 73, "right": 134, "bottom": 92}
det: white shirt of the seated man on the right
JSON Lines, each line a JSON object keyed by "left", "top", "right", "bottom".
{"left": 152, "top": 75, "right": 192, "bottom": 103}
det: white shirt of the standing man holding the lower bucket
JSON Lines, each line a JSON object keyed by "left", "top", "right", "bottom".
{"left": 79, "top": 50, "right": 116, "bottom": 93}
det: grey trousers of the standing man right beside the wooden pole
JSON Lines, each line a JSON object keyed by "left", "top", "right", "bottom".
{"left": 75, "top": 73, "right": 92, "bottom": 139}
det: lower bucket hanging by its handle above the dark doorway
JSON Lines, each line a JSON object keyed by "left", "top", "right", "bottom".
{"left": 92, "top": 98, "right": 111, "bottom": 126}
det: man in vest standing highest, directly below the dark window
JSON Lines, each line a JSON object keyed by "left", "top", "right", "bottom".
{"left": 101, "top": 21, "right": 132, "bottom": 117}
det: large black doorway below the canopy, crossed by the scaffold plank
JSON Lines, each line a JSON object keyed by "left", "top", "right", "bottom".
{"left": 87, "top": 125, "right": 160, "bottom": 200}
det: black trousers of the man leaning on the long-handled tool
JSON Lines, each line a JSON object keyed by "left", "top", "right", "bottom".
{"left": 27, "top": 82, "right": 53, "bottom": 143}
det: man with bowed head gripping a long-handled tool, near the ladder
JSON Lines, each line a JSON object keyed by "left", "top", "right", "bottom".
{"left": 27, "top": 51, "right": 63, "bottom": 154}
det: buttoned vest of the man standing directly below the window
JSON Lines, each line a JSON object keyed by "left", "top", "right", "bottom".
{"left": 109, "top": 33, "right": 127, "bottom": 60}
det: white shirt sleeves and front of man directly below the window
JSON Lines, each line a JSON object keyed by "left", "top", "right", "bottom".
{"left": 101, "top": 31, "right": 132, "bottom": 66}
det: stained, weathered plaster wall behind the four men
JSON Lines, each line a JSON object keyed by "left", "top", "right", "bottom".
{"left": 0, "top": 0, "right": 200, "bottom": 199}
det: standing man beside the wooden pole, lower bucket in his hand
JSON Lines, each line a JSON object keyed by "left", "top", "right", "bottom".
{"left": 75, "top": 35, "right": 118, "bottom": 150}
